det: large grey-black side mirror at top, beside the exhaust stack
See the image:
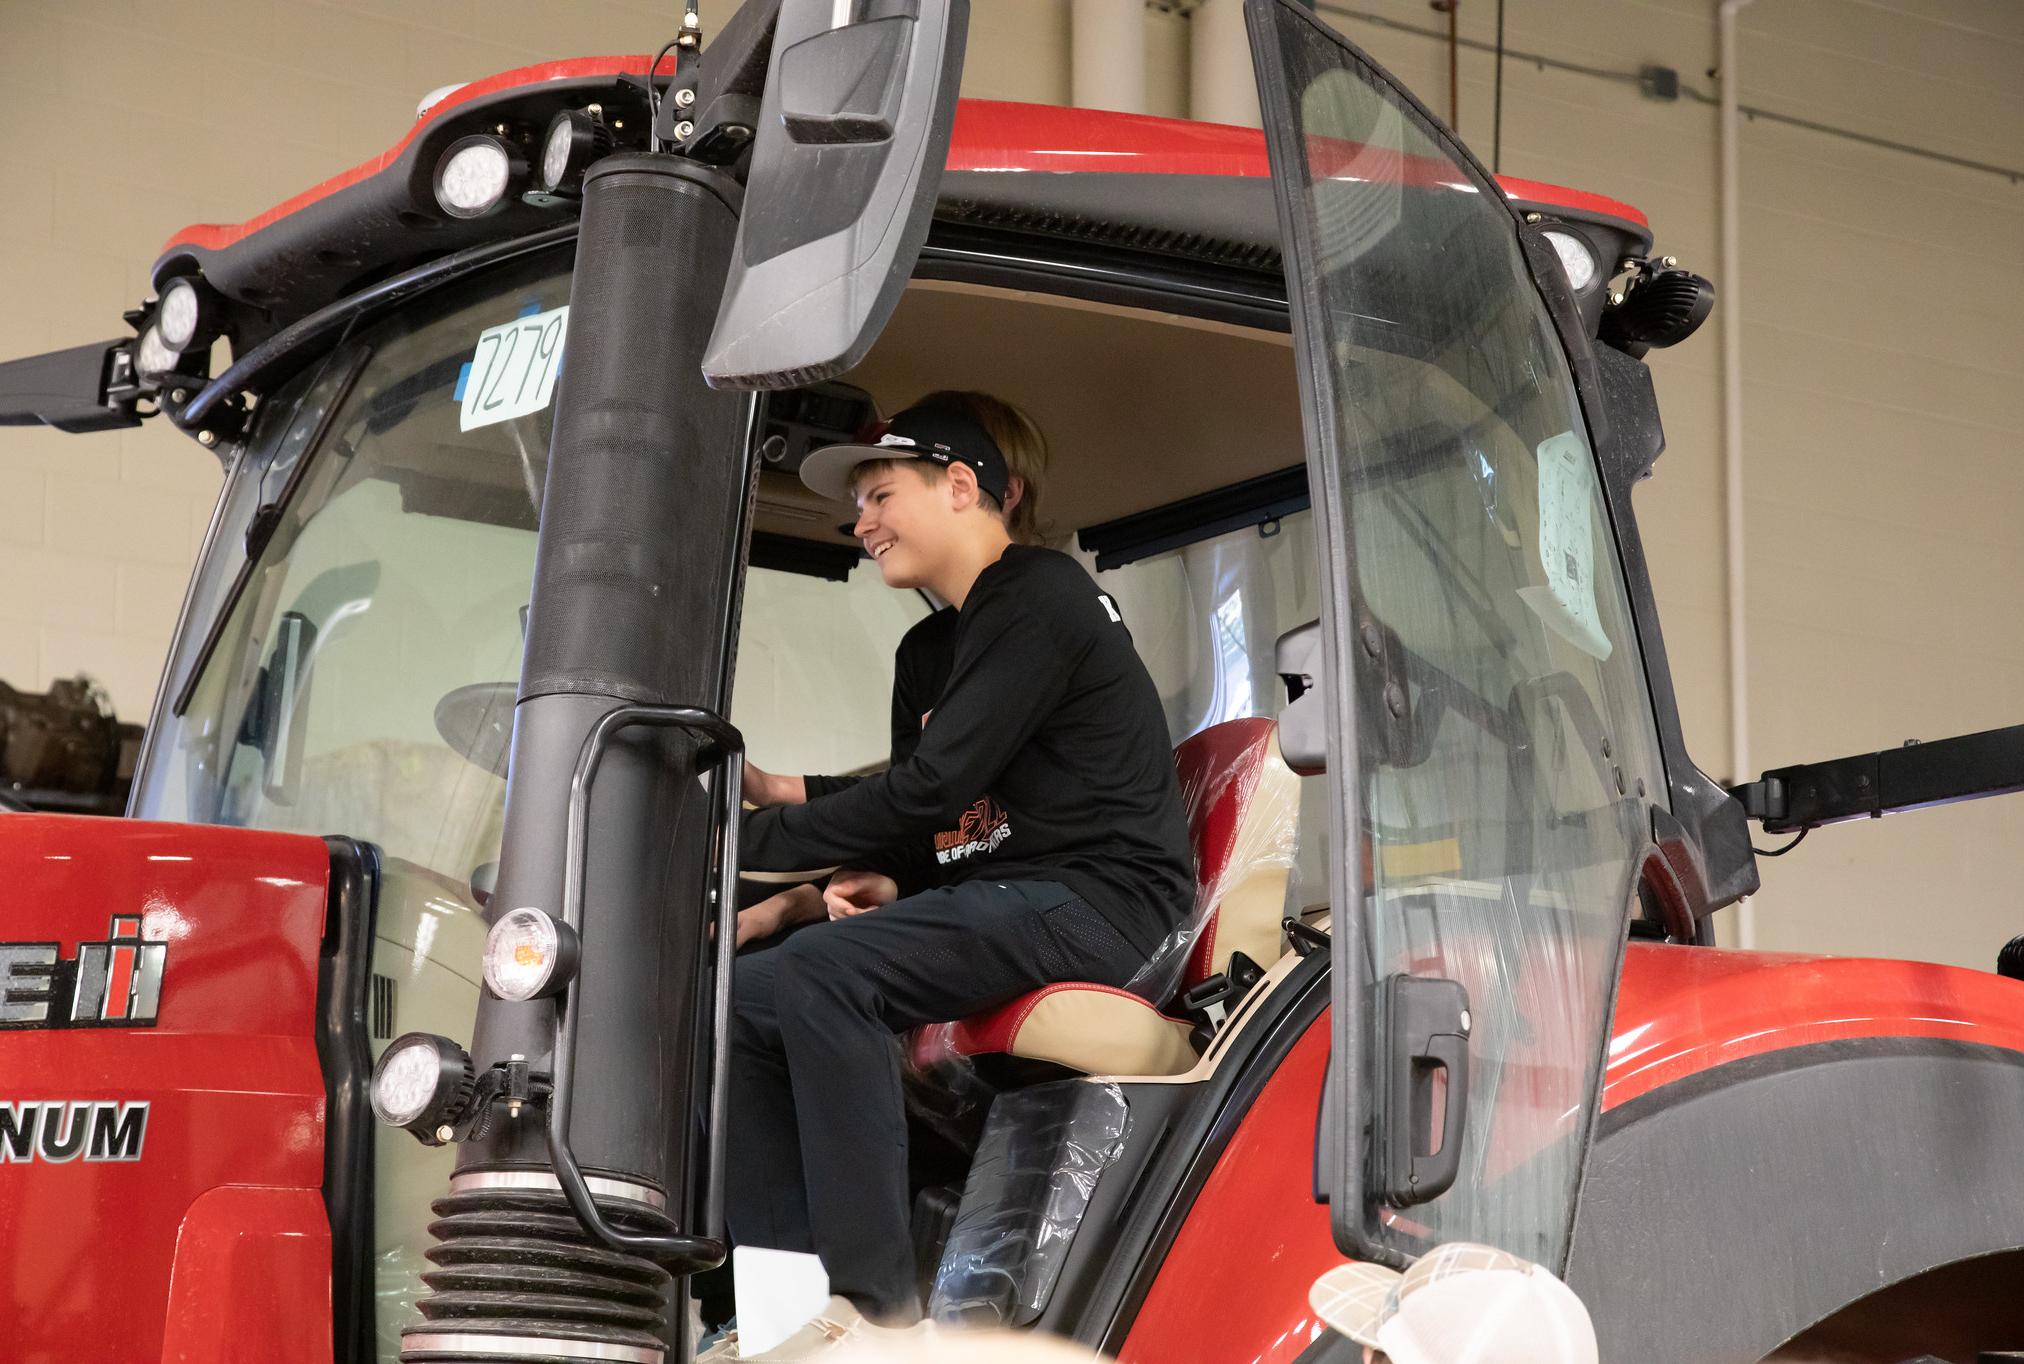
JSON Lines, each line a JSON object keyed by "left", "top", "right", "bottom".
{"left": 702, "top": 0, "right": 969, "bottom": 389}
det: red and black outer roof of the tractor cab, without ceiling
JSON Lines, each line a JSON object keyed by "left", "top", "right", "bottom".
{"left": 154, "top": 57, "right": 1650, "bottom": 336}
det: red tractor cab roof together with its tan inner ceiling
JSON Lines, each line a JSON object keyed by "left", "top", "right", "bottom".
{"left": 154, "top": 57, "right": 1650, "bottom": 571}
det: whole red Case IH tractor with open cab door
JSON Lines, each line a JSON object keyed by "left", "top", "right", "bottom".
{"left": 0, "top": 0, "right": 2024, "bottom": 1364}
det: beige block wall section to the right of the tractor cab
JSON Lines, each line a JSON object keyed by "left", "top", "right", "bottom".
{"left": 1318, "top": 0, "right": 2024, "bottom": 967}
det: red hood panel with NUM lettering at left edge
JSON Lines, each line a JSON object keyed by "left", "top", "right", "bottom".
{"left": 0, "top": 814, "right": 330, "bottom": 1364}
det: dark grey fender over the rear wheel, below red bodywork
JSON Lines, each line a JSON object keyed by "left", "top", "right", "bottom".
{"left": 1567, "top": 1038, "right": 2024, "bottom": 1364}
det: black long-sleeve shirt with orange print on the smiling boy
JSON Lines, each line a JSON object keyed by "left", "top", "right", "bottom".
{"left": 741, "top": 544, "right": 1194, "bottom": 951}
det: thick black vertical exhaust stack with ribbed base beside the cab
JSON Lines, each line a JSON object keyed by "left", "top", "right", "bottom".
{"left": 401, "top": 154, "right": 755, "bottom": 1364}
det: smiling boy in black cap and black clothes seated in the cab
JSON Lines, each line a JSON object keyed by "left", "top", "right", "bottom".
{"left": 729, "top": 405, "right": 1194, "bottom": 1358}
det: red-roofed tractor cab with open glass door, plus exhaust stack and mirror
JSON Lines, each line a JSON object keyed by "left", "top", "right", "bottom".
{"left": 0, "top": 0, "right": 2023, "bottom": 1362}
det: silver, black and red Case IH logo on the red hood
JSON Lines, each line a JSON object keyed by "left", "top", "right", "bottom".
{"left": 0, "top": 915, "right": 168, "bottom": 1028}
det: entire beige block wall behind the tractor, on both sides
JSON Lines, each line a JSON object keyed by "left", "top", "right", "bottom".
{"left": 0, "top": 0, "right": 2024, "bottom": 965}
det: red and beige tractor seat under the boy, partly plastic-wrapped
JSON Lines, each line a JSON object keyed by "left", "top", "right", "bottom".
{"left": 915, "top": 718, "right": 1299, "bottom": 1075}
